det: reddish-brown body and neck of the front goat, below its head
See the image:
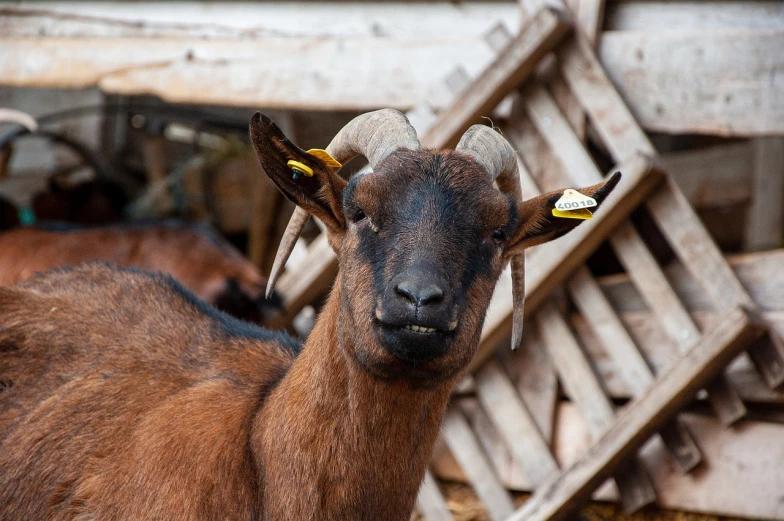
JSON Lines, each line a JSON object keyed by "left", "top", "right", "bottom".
{"left": 0, "top": 264, "right": 449, "bottom": 520}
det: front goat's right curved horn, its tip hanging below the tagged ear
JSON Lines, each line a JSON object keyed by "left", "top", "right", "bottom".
{"left": 455, "top": 125, "right": 525, "bottom": 349}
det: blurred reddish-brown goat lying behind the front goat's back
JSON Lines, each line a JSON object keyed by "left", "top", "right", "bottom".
{"left": 0, "top": 220, "right": 279, "bottom": 323}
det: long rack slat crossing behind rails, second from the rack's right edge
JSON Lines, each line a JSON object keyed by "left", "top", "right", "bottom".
{"left": 522, "top": 84, "right": 746, "bottom": 424}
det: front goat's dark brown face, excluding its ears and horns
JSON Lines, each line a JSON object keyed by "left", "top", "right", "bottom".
{"left": 340, "top": 150, "right": 516, "bottom": 385}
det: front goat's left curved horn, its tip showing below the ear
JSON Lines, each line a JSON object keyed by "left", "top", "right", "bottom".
{"left": 267, "top": 109, "right": 420, "bottom": 298}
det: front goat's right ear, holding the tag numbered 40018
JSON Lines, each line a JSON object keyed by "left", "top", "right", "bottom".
{"left": 504, "top": 172, "right": 621, "bottom": 255}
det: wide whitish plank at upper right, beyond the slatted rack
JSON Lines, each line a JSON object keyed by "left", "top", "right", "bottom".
{"left": 599, "top": 30, "right": 784, "bottom": 135}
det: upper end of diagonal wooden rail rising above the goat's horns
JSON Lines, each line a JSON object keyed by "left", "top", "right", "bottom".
{"left": 420, "top": 8, "right": 571, "bottom": 148}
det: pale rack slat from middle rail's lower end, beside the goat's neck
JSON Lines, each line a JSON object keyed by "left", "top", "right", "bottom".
{"left": 474, "top": 361, "right": 558, "bottom": 486}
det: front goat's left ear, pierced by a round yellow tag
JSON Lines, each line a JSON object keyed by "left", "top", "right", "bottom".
{"left": 250, "top": 112, "right": 347, "bottom": 232}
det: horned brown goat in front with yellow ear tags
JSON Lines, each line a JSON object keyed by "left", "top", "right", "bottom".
{"left": 0, "top": 110, "right": 618, "bottom": 521}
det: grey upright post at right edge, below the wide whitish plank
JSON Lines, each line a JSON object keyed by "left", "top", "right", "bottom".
{"left": 745, "top": 136, "right": 784, "bottom": 250}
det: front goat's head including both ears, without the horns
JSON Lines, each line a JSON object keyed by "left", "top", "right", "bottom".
{"left": 251, "top": 109, "right": 618, "bottom": 385}
